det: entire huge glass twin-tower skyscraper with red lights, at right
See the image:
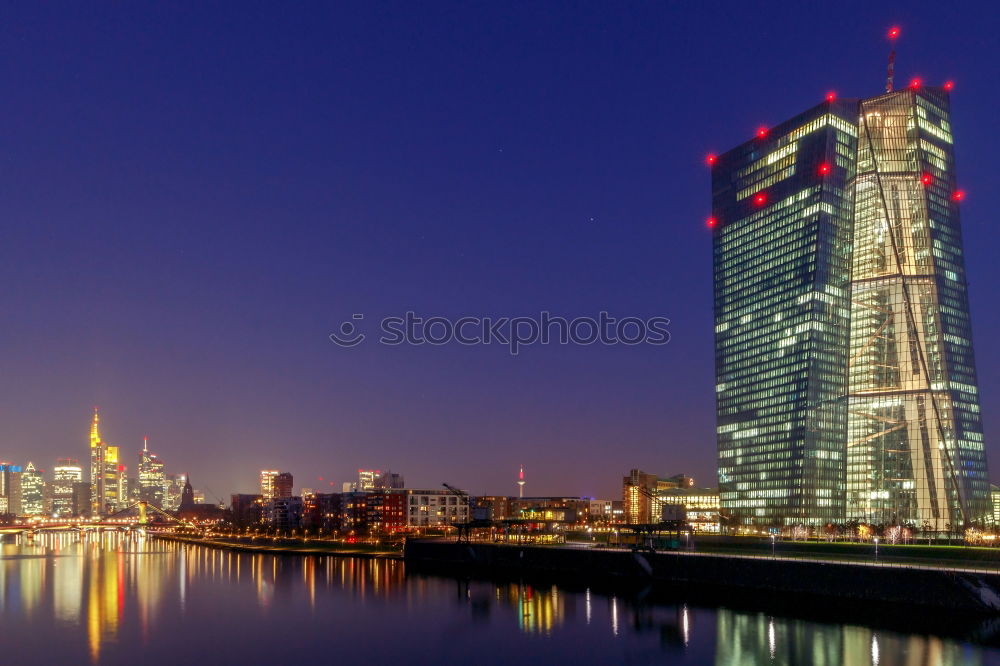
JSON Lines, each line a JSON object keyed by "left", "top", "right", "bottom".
{"left": 709, "top": 75, "right": 989, "bottom": 530}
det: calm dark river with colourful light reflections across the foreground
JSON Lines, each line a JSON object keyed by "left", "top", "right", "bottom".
{"left": 0, "top": 534, "right": 1000, "bottom": 666}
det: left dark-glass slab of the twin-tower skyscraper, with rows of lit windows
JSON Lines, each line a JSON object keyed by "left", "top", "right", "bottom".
{"left": 709, "top": 99, "right": 857, "bottom": 525}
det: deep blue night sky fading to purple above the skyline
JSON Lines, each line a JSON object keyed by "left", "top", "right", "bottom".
{"left": 0, "top": 2, "right": 1000, "bottom": 497}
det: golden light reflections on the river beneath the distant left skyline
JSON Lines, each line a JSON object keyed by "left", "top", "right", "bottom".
{"left": 0, "top": 530, "right": 408, "bottom": 662}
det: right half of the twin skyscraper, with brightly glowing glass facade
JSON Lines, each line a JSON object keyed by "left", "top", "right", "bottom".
{"left": 847, "top": 88, "right": 989, "bottom": 531}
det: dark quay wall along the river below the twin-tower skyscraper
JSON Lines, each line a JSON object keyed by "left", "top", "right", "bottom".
{"left": 403, "top": 539, "right": 1000, "bottom": 615}
